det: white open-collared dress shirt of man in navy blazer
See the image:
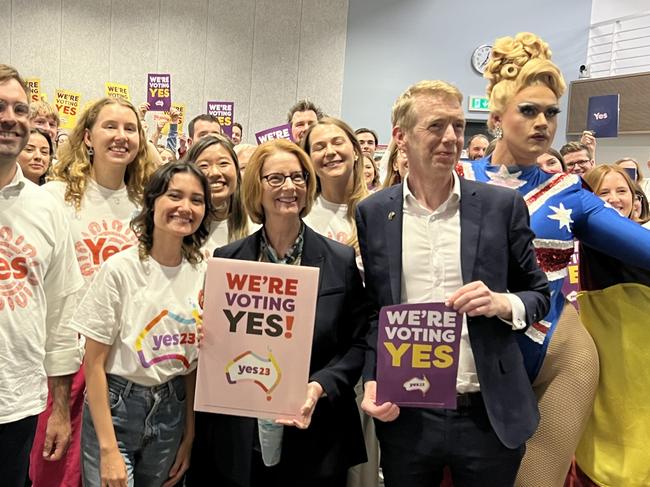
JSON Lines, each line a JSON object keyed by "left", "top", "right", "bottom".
{"left": 401, "top": 171, "right": 526, "bottom": 394}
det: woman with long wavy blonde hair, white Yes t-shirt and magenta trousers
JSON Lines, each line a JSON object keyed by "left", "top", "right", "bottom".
{"left": 30, "top": 98, "right": 156, "bottom": 487}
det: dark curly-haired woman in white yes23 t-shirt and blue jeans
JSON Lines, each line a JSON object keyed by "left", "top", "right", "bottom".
{"left": 72, "top": 162, "right": 211, "bottom": 487}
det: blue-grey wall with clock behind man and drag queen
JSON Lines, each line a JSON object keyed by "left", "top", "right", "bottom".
{"left": 342, "top": 0, "right": 591, "bottom": 147}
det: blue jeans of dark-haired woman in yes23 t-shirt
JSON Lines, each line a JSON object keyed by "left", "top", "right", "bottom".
{"left": 81, "top": 375, "right": 185, "bottom": 487}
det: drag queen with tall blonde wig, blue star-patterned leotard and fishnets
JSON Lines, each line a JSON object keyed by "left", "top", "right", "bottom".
{"left": 458, "top": 33, "right": 650, "bottom": 487}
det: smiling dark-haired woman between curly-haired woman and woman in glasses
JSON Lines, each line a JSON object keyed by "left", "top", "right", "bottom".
{"left": 184, "top": 135, "right": 252, "bottom": 258}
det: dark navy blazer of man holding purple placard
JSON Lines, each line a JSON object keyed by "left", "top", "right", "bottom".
{"left": 356, "top": 179, "right": 549, "bottom": 448}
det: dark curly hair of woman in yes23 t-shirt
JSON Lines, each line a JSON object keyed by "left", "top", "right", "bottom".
{"left": 131, "top": 161, "right": 212, "bottom": 264}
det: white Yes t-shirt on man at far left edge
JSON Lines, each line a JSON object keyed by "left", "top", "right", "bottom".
{"left": 0, "top": 166, "right": 83, "bottom": 424}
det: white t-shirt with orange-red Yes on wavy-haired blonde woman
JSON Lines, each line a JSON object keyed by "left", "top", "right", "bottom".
{"left": 43, "top": 178, "right": 138, "bottom": 284}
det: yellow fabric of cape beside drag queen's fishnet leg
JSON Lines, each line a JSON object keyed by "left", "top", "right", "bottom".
{"left": 576, "top": 284, "right": 650, "bottom": 487}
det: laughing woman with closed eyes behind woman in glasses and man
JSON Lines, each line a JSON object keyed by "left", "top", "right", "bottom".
{"left": 301, "top": 117, "right": 368, "bottom": 250}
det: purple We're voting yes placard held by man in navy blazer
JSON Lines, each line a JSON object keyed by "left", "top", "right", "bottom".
{"left": 377, "top": 303, "right": 463, "bottom": 409}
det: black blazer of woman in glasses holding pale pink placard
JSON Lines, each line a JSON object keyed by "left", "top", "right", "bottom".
{"left": 188, "top": 226, "right": 368, "bottom": 486}
